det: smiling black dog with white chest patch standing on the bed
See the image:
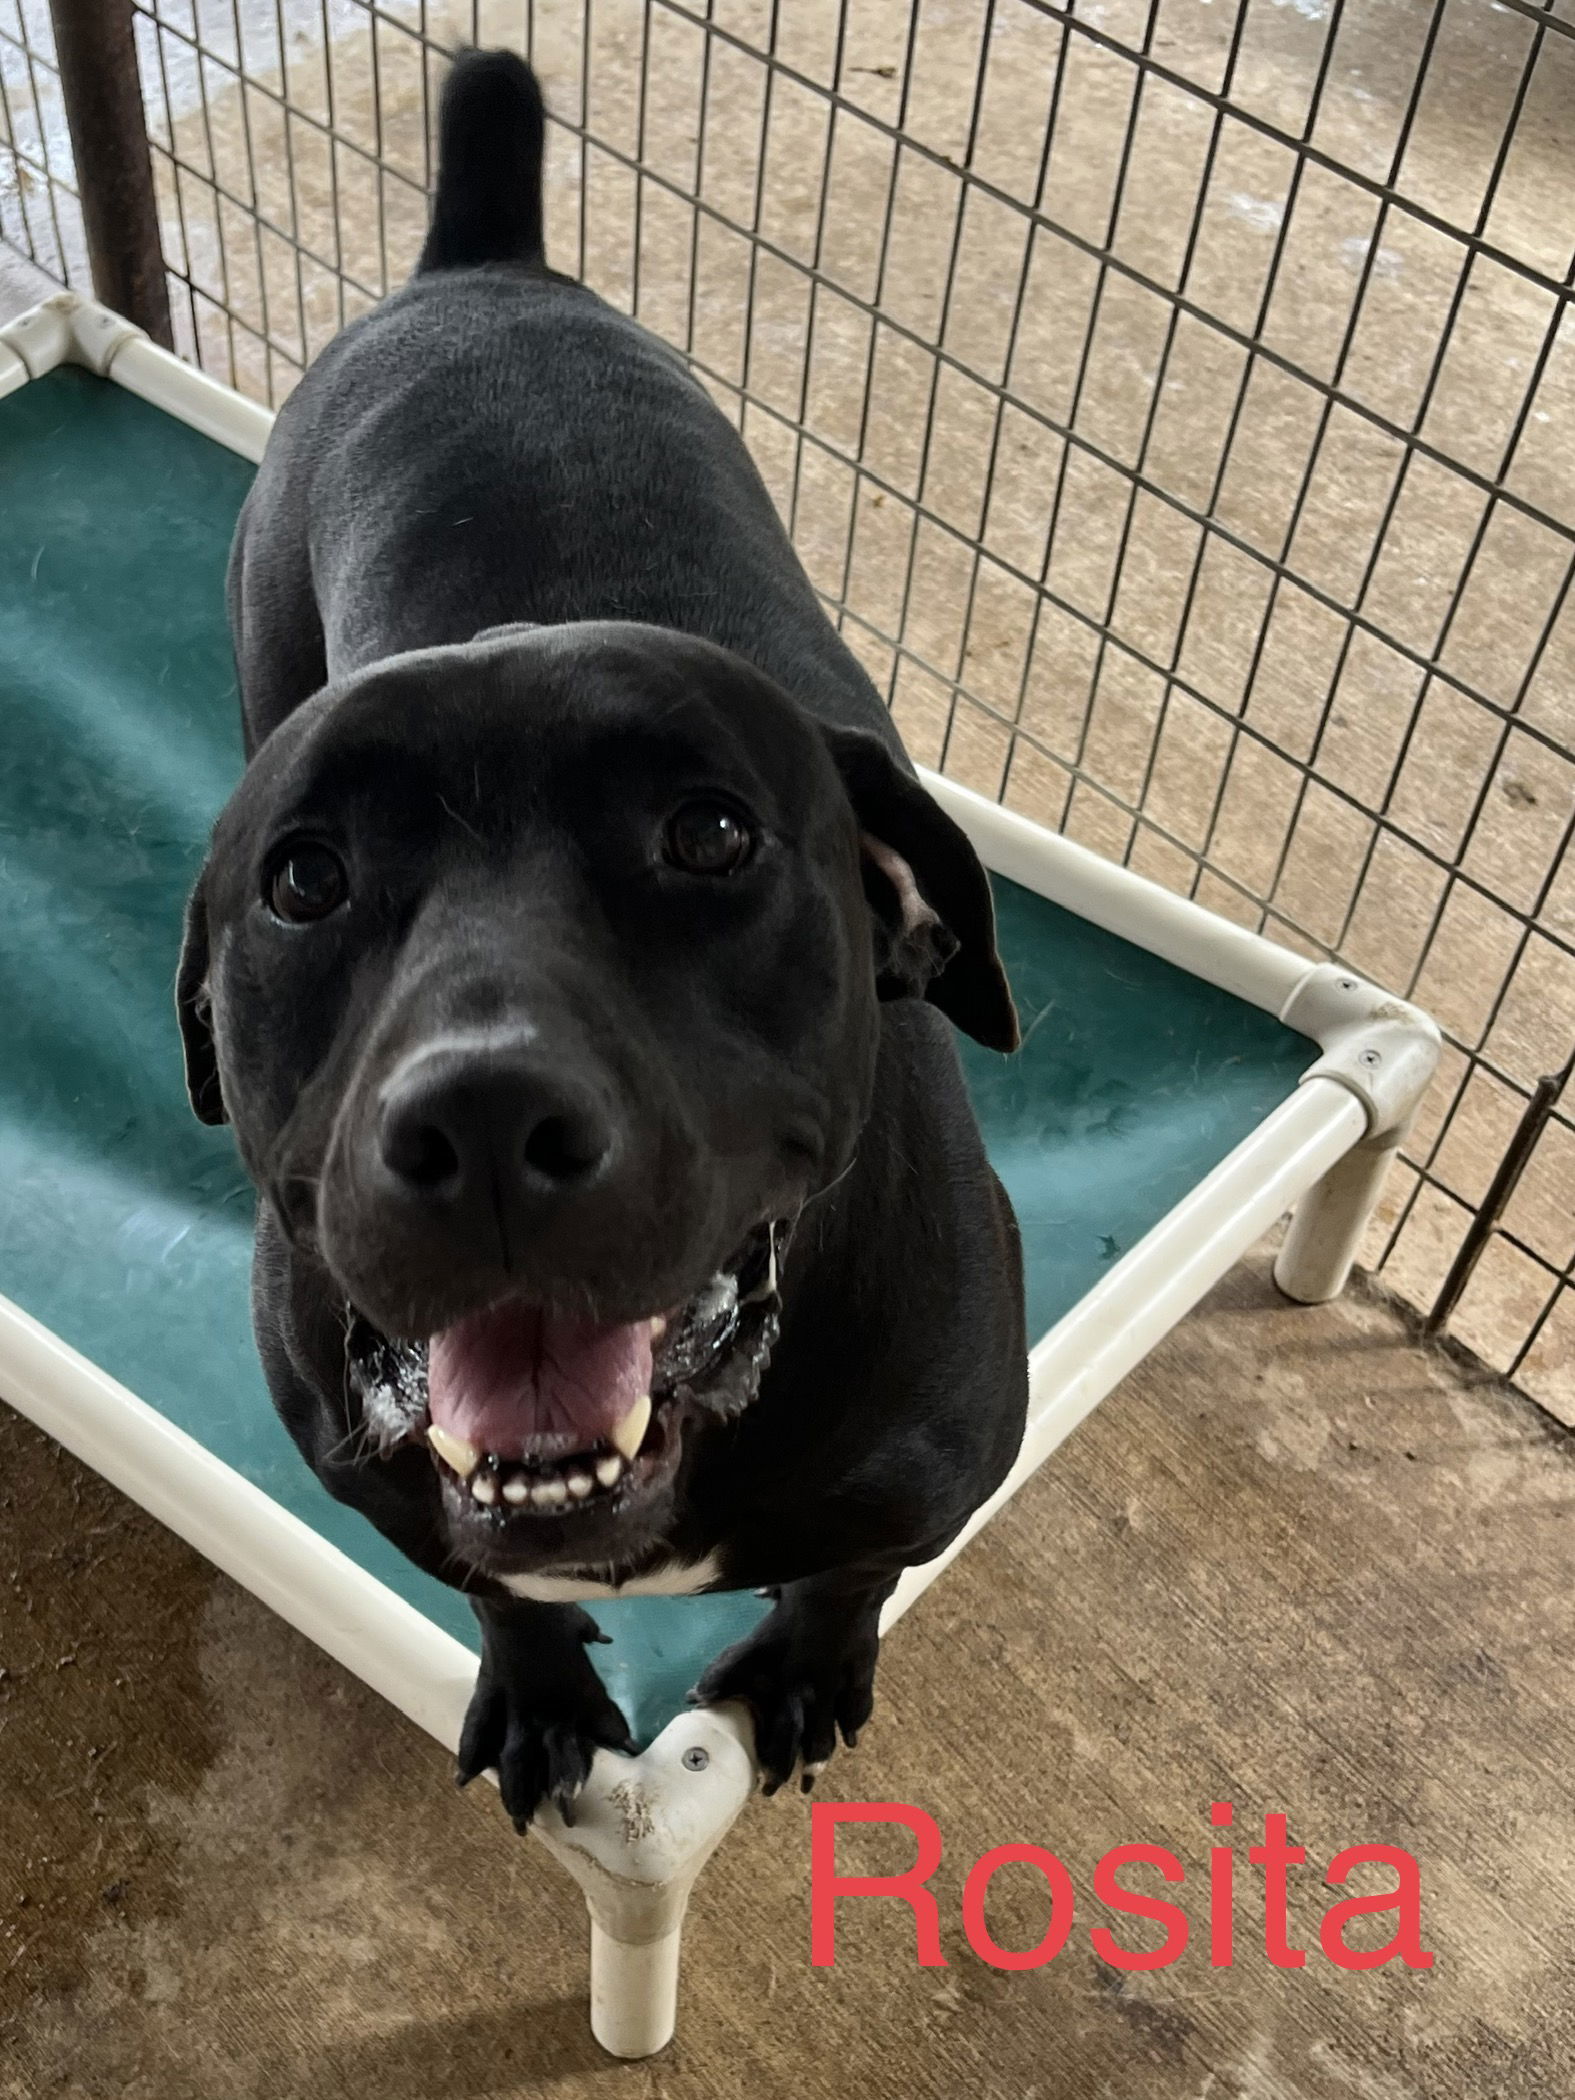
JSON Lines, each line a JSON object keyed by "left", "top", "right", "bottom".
{"left": 179, "top": 53, "right": 1027, "bottom": 1827}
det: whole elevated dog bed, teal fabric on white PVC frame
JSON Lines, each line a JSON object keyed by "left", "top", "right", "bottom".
{"left": 0, "top": 298, "right": 1436, "bottom": 2056}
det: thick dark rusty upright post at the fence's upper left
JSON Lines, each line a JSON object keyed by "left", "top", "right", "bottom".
{"left": 48, "top": 0, "right": 172, "bottom": 349}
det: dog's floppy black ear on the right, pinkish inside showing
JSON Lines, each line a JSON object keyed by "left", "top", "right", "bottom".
{"left": 821, "top": 727, "right": 1021, "bottom": 1050}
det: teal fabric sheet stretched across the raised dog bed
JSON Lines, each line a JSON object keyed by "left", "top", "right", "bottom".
{"left": 0, "top": 370, "right": 1310, "bottom": 1739}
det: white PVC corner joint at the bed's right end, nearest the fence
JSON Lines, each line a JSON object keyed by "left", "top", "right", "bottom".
{"left": 1279, "top": 962, "right": 1443, "bottom": 1145}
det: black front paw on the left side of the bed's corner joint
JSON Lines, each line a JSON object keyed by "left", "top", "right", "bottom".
{"left": 454, "top": 1612, "right": 634, "bottom": 1833}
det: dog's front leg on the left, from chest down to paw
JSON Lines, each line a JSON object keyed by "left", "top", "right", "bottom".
{"left": 456, "top": 1598, "right": 634, "bottom": 1831}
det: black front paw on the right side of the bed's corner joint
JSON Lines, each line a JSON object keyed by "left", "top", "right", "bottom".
{"left": 689, "top": 1604, "right": 880, "bottom": 1793}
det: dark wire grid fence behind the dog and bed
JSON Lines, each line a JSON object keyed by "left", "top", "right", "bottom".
{"left": 0, "top": 0, "right": 1575, "bottom": 1424}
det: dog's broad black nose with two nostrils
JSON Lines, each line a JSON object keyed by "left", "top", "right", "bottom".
{"left": 378, "top": 1052, "right": 617, "bottom": 1210}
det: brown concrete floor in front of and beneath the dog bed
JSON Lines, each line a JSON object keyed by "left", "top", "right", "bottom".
{"left": 0, "top": 1260, "right": 1575, "bottom": 2100}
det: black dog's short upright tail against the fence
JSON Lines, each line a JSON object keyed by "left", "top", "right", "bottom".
{"left": 416, "top": 50, "right": 546, "bottom": 275}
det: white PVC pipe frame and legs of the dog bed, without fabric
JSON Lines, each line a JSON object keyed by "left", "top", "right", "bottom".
{"left": 0, "top": 304, "right": 1439, "bottom": 2056}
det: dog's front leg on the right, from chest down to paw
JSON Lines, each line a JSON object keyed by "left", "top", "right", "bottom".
{"left": 691, "top": 1569, "right": 897, "bottom": 1793}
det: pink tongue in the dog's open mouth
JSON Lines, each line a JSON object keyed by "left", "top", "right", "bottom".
{"left": 426, "top": 1306, "right": 651, "bottom": 1457}
